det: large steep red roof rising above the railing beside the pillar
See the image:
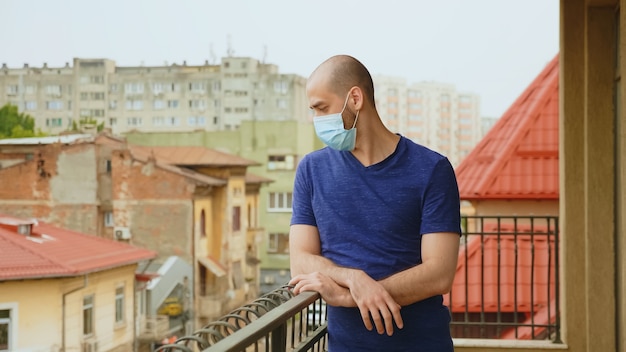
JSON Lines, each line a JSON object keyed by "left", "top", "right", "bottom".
{"left": 456, "top": 55, "right": 559, "bottom": 200}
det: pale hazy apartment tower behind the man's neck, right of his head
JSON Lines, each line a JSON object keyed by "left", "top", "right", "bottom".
{"left": 373, "top": 76, "right": 482, "bottom": 166}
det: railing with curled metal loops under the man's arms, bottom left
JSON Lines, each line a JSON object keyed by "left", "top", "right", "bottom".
{"left": 155, "top": 286, "right": 327, "bottom": 352}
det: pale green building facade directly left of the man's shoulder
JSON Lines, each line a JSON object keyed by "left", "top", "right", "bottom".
{"left": 126, "top": 121, "right": 323, "bottom": 293}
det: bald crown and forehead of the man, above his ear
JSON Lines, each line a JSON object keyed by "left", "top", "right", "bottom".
{"left": 308, "top": 55, "right": 374, "bottom": 106}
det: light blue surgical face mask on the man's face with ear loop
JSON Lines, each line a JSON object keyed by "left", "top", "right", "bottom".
{"left": 313, "top": 94, "right": 359, "bottom": 151}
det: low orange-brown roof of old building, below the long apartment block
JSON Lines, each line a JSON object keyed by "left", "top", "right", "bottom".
{"left": 129, "top": 145, "right": 259, "bottom": 166}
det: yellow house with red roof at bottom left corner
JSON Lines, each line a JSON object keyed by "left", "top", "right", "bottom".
{"left": 0, "top": 214, "right": 156, "bottom": 352}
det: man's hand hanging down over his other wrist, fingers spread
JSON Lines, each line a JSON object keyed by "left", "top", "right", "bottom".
{"left": 350, "top": 271, "right": 404, "bottom": 336}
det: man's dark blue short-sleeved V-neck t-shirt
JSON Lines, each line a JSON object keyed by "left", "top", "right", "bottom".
{"left": 291, "top": 137, "right": 461, "bottom": 352}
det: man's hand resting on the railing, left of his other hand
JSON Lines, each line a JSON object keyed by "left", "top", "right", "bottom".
{"left": 289, "top": 272, "right": 356, "bottom": 307}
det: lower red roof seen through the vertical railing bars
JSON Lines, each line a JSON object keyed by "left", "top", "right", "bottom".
{"left": 444, "top": 228, "right": 555, "bottom": 313}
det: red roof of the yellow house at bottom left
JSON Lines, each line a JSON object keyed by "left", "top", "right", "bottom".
{"left": 0, "top": 214, "right": 156, "bottom": 281}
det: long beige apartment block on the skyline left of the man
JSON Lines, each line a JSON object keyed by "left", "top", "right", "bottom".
{"left": 0, "top": 57, "right": 307, "bottom": 134}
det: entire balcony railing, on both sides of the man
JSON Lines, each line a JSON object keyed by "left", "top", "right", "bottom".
{"left": 156, "top": 216, "right": 561, "bottom": 352}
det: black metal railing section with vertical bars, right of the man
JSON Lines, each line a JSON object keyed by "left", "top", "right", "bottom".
{"left": 445, "top": 216, "right": 561, "bottom": 343}
